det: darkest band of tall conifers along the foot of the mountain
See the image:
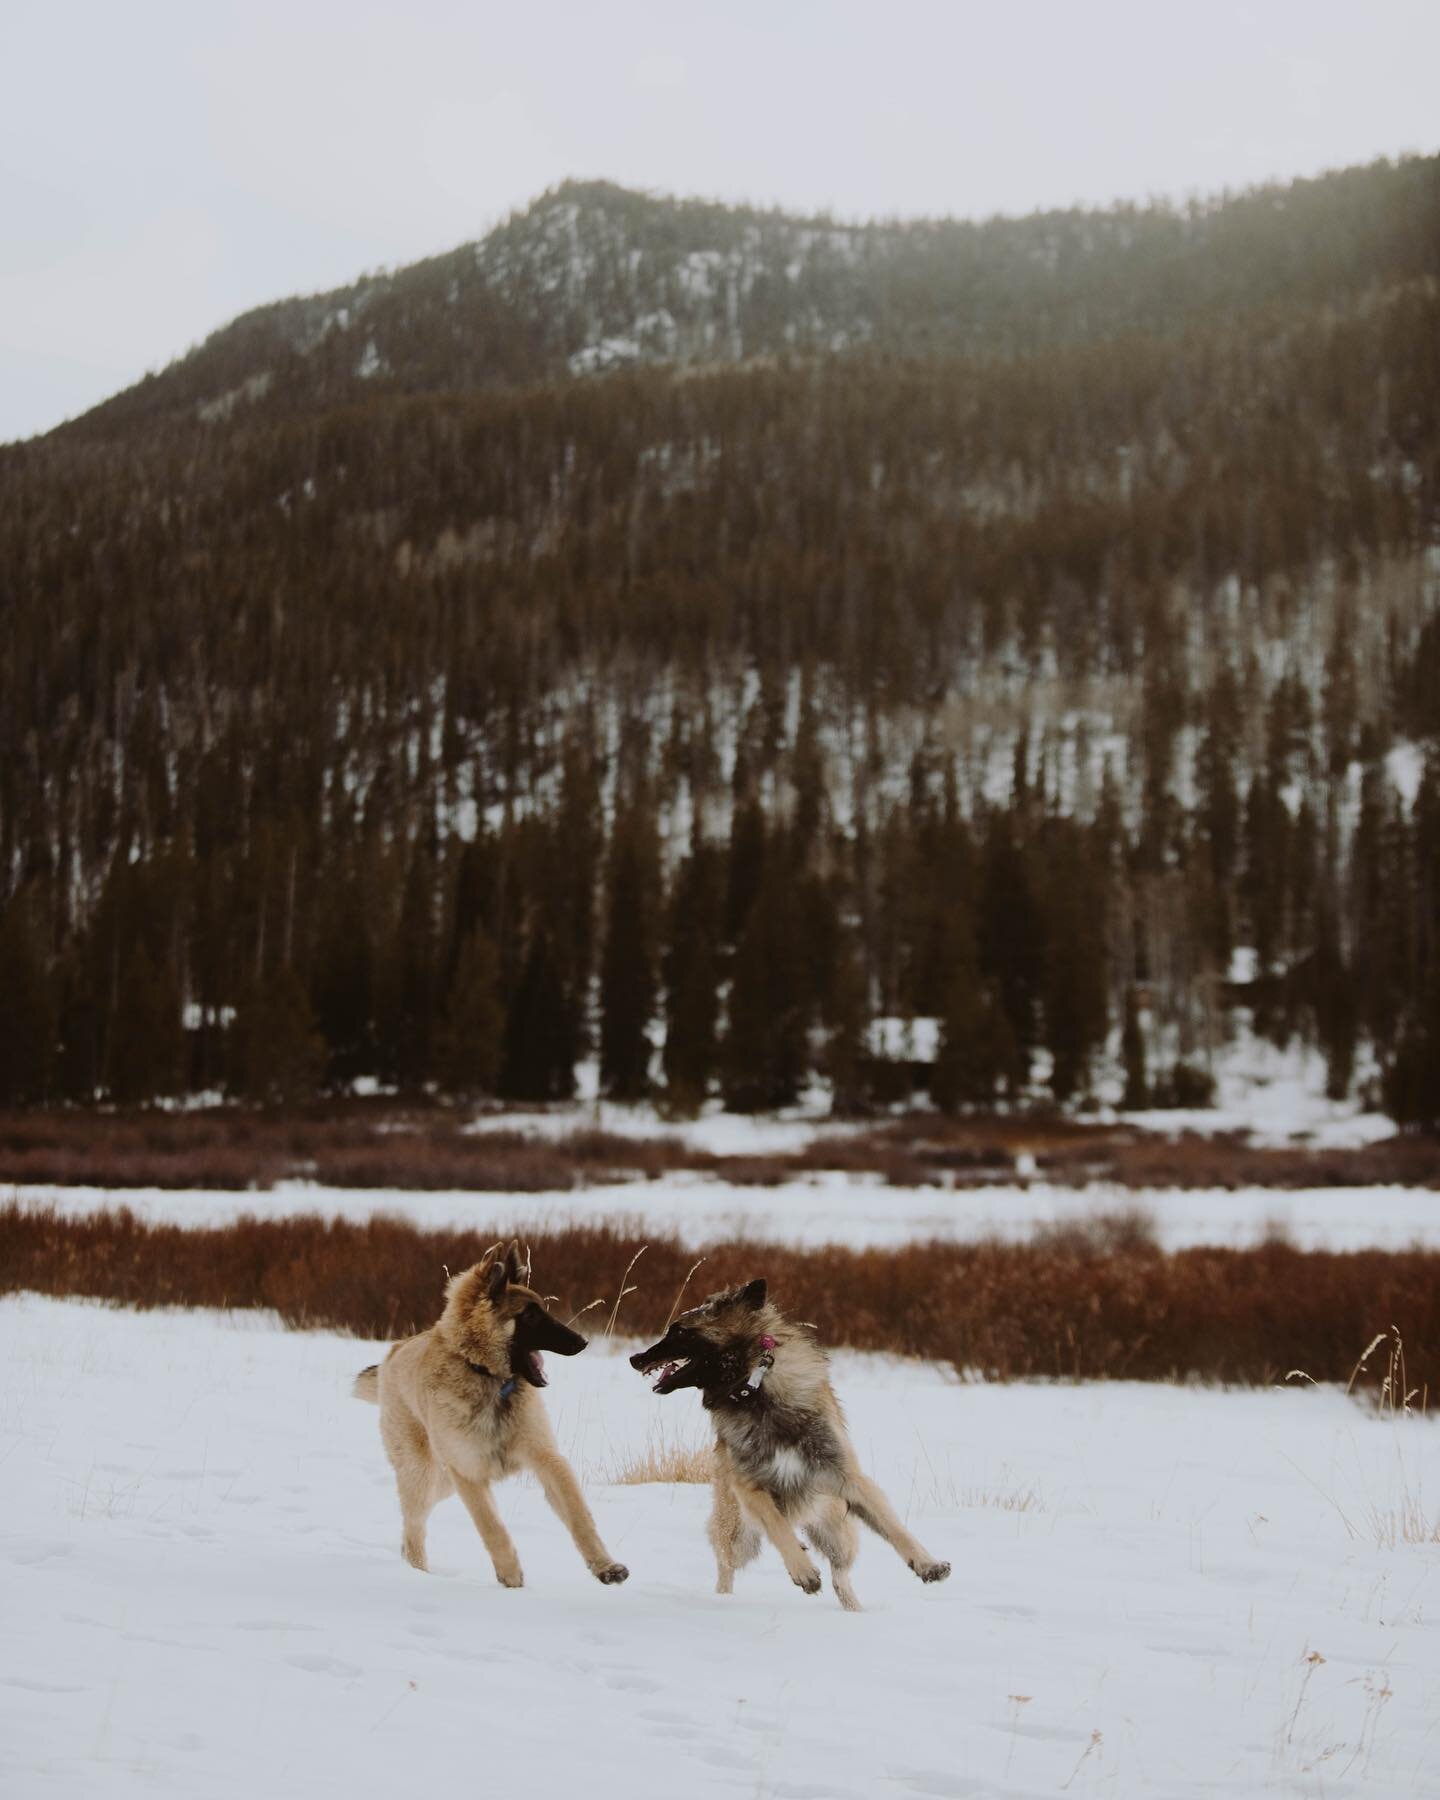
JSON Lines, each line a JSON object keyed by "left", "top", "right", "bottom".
{"left": 0, "top": 720, "right": 1440, "bottom": 1123}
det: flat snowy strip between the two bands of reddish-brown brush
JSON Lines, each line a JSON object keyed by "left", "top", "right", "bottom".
{"left": 20, "top": 1172, "right": 1440, "bottom": 1249}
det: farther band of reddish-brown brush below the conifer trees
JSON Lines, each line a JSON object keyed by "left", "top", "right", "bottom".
{"left": 0, "top": 1098, "right": 1440, "bottom": 1193}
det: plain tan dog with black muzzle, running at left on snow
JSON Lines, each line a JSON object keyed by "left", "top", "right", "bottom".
{"left": 353, "top": 1244, "right": 630, "bottom": 1588}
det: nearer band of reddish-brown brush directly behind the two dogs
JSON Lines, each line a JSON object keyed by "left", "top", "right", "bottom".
{"left": 0, "top": 1204, "right": 1440, "bottom": 1390}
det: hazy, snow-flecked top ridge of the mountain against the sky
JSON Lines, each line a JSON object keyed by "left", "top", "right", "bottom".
{"left": 58, "top": 157, "right": 1440, "bottom": 448}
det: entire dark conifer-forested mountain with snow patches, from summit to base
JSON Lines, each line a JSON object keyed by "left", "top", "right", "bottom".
{"left": 0, "top": 158, "right": 1440, "bottom": 1118}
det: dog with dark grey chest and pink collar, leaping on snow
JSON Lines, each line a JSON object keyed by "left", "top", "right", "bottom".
{"left": 630, "top": 1282, "right": 950, "bottom": 1613}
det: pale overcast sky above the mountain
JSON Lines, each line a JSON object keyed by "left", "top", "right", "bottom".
{"left": 0, "top": 0, "right": 1440, "bottom": 441}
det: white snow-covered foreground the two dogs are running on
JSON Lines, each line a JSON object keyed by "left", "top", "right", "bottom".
{"left": 0, "top": 1296, "right": 1440, "bottom": 1800}
